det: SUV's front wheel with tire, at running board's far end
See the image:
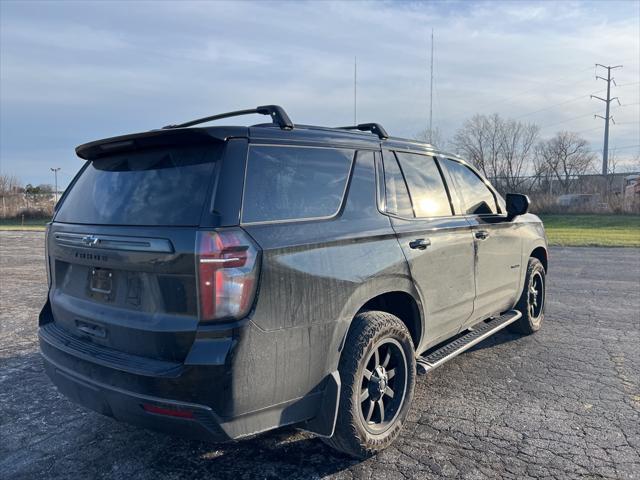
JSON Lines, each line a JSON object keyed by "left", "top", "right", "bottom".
{"left": 507, "top": 258, "right": 546, "bottom": 335}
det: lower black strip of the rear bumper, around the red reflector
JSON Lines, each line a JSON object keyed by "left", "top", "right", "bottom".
{"left": 41, "top": 348, "right": 230, "bottom": 442}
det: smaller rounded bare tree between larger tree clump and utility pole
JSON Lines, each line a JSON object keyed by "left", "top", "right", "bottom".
{"left": 535, "top": 132, "right": 596, "bottom": 192}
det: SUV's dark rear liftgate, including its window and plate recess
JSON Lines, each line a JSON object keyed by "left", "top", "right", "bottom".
{"left": 47, "top": 142, "right": 225, "bottom": 361}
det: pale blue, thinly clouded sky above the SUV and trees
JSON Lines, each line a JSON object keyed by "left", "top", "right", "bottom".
{"left": 0, "top": 0, "right": 640, "bottom": 188}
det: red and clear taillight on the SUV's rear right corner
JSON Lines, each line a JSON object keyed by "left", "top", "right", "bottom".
{"left": 196, "top": 228, "right": 260, "bottom": 321}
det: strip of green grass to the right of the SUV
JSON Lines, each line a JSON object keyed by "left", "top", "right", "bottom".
{"left": 540, "top": 214, "right": 640, "bottom": 247}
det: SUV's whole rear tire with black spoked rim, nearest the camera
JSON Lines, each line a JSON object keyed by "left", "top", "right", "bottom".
{"left": 323, "top": 311, "right": 416, "bottom": 459}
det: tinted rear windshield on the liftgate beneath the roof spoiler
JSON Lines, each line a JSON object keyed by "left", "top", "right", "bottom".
{"left": 55, "top": 146, "right": 222, "bottom": 226}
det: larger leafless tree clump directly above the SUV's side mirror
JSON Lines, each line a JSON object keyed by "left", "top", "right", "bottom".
{"left": 453, "top": 113, "right": 539, "bottom": 190}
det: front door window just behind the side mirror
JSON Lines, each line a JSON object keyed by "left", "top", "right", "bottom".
{"left": 442, "top": 159, "right": 498, "bottom": 215}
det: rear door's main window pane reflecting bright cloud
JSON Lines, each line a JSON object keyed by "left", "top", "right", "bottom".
{"left": 396, "top": 152, "right": 451, "bottom": 217}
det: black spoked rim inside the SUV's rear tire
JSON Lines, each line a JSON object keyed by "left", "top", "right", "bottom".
{"left": 358, "top": 338, "right": 407, "bottom": 434}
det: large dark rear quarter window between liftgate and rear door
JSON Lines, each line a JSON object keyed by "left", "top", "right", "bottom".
{"left": 242, "top": 146, "right": 353, "bottom": 222}
